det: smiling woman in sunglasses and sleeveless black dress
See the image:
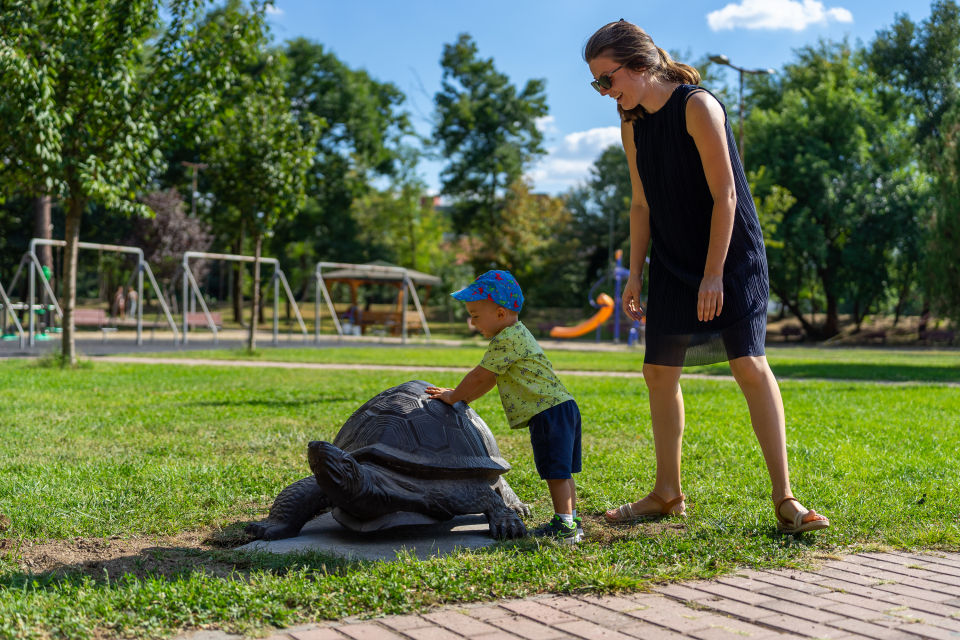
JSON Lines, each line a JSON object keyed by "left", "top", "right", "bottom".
{"left": 583, "top": 20, "right": 830, "bottom": 533}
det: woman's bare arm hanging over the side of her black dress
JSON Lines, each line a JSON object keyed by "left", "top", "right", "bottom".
{"left": 686, "top": 91, "right": 737, "bottom": 321}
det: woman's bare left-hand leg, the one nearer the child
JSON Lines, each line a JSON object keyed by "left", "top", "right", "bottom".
{"left": 607, "top": 364, "right": 684, "bottom": 518}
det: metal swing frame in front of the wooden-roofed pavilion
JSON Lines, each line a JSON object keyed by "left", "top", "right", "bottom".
{"left": 314, "top": 262, "right": 440, "bottom": 344}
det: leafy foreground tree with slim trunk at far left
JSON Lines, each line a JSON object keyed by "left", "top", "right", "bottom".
{"left": 0, "top": 0, "right": 263, "bottom": 364}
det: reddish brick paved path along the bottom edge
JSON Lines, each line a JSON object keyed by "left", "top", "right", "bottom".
{"left": 185, "top": 553, "right": 960, "bottom": 640}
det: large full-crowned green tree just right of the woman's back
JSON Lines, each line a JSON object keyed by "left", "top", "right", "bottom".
{"left": 750, "top": 42, "right": 918, "bottom": 338}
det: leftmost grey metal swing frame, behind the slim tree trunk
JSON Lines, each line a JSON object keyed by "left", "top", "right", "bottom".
{"left": 7, "top": 238, "right": 179, "bottom": 348}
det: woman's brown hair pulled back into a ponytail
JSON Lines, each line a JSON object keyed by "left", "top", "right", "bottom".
{"left": 583, "top": 18, "right": 700, "bottom": 122}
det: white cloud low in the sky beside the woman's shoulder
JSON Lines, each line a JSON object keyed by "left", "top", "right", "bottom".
{"left": 529, "top": 126, "right": 620, "bottom": 193}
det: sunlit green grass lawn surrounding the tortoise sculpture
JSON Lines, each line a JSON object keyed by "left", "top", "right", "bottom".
{"left": 0, "top": 362, "right": 960, "bottom": 638}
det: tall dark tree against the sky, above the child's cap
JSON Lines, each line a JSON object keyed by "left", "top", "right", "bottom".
{"left": 433, "top": 33, "right": 547, "bottom": 238}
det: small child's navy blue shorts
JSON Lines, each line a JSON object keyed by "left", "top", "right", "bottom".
{"left": 527, "top": 400, "right": 580, "bottom": 480}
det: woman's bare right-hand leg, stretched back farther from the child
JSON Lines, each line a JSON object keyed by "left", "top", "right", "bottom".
{"left": 730, "top": 356, "right": 825, "bottom": 522}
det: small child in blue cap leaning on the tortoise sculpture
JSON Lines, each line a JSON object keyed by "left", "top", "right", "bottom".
{"left": 427, "top": 271, "right": 583, "bottom": 544}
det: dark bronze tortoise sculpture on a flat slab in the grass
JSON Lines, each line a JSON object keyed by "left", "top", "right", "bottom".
{"left": 247, "top": 381, "right": 530, "bottom": 540}
